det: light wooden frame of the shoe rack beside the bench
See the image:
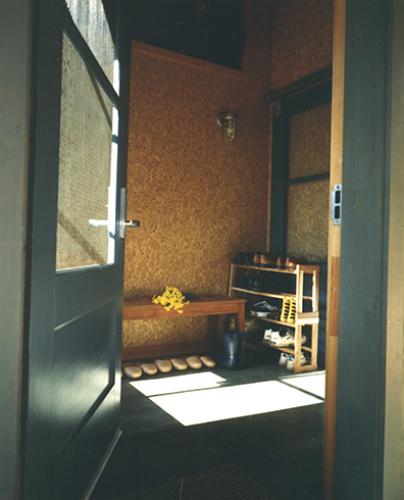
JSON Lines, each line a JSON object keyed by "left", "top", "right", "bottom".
{"left": 229, "top": 264, "right": 320, "bottom": 373}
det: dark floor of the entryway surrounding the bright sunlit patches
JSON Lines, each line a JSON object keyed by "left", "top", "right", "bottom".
{"left": 92, "top": 352, "right": 323, "bottom": 500}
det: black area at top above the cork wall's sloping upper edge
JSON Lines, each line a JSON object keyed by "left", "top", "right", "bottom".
{"left": 124, "top": 0, "right": 245, "bottom": 69}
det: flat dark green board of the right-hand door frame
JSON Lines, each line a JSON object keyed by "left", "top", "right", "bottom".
{"left": 334, "top": 0, "right": 392, "bottom": 500}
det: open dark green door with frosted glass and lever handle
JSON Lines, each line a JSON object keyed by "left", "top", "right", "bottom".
{"left": 23, "top": 0, "right": 127, "bottom": 500}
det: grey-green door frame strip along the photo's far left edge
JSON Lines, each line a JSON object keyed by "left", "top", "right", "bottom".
{"left": 0, "top": 0, "right": 32, "bottom": 499}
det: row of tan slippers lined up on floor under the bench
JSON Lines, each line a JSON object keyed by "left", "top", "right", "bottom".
{"left": 123, "top": 356, "right": 216, "bottom": 379}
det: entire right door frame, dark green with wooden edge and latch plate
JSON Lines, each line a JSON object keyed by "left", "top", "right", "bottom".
{"left": 325, "top": 0, "right": 404, "bottom": 500}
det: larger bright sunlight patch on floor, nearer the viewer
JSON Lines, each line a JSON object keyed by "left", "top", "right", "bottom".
{"left": 150, "top": 380, "right": 323, "bottom": 426}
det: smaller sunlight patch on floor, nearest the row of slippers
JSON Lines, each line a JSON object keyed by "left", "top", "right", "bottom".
{"left": 130, "top": 372, "right": 226, "bottom": 396}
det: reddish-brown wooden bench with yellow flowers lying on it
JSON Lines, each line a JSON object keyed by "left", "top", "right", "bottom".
{"left": 122, "top": 295, "right": 246, "bottom": 360}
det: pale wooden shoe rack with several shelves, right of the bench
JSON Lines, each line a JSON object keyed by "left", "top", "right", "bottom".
{"left": 228, "top": 263, "right": 320, "bottom": 373}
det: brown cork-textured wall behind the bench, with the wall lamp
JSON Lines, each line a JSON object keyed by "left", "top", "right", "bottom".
{"left": 124, "top": 2, "right": 269, "bottom": 347}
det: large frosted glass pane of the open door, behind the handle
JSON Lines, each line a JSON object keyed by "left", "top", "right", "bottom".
{"left": 56, "top": 35, "right": 117, "bottom": 270}
